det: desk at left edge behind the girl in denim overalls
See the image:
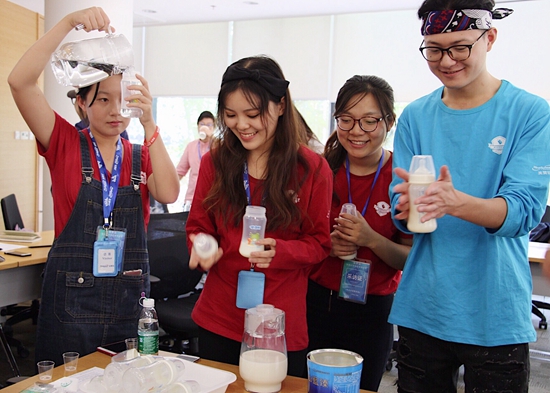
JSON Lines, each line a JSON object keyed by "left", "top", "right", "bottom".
{"left": 0, "top": 231, "right": 54, "bottom": 307}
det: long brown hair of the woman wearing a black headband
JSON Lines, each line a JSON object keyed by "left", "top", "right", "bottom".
{"left": 203, "top": 56, "right": 310, "bottom": 230}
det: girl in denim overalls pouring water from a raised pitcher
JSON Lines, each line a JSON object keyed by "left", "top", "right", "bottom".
{"left": 8, "top": 7, "right": 179, "bottom": 364}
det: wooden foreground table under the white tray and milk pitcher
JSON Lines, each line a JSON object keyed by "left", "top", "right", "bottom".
{"left": 0, "top": 352, "right": 378, "bottom": 393}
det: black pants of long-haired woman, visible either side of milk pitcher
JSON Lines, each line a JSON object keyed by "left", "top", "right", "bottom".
{"left": 199, "top": 327, "right": 307, "bottom": 377}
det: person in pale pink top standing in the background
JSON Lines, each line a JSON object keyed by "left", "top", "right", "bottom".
{"left": 176, "top": 111, "right": 216, "bottom": 211}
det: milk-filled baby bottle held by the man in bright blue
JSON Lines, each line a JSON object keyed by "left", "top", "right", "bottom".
{"left": 407, "top": 155, "right": 437, "bottom": 233}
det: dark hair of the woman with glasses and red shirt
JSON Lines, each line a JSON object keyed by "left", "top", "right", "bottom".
{"left": 323, "top": 75, "right": 396, "bottom": 175}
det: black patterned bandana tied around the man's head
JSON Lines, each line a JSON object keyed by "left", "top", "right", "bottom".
{"left": 421, "top": 8, "right": 514, "bottom": 36}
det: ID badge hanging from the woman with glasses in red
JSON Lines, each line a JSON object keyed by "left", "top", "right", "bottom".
{"left": 338, "top": 261, "right": 371, "bottom": 304}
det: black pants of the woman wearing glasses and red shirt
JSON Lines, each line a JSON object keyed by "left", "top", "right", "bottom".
{"left": 307, "top": 281, "right": 393, "bottom": 391}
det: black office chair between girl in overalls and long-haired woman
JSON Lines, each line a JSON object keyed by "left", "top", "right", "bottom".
{"left": 147, "top": 212, "right": 203, "bottom": 354}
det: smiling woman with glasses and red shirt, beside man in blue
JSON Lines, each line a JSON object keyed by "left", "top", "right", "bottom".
{"left": 307, "top": 75, "right": 411, "bottom": 391}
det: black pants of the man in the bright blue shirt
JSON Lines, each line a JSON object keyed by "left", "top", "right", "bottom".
{"left": 397, "top": 326, "right": 529, "bottom": 393}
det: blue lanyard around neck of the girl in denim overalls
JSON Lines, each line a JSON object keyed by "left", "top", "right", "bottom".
{"left": 88, "top": 128, "right": 122, "bottom": 228}
